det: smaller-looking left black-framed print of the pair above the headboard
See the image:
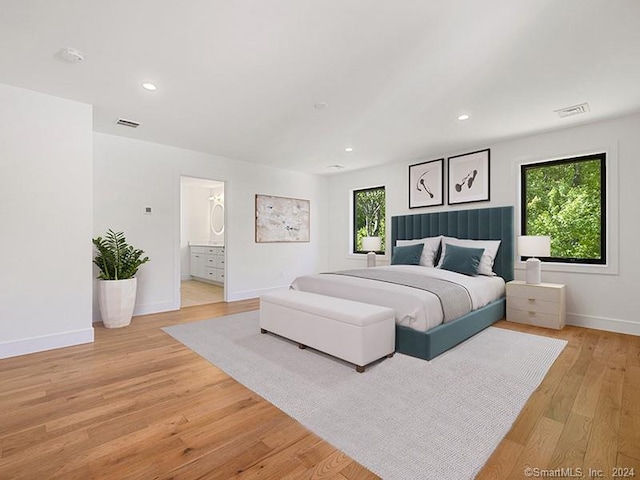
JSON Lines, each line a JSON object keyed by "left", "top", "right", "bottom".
{"left": 409, "top": 158, "right": 444, "bottom": 208}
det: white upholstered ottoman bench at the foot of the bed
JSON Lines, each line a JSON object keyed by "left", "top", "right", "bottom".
{"left": 260, "top": 290, "right": 396, "bottom": 373}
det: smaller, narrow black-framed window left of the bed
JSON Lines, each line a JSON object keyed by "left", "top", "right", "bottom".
{"left": 353, "top": 187, "right": 386, "bottom": 253}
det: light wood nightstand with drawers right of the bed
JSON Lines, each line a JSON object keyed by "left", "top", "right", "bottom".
{"left": 507, "top": 280, "right": 566, "bottom": 330}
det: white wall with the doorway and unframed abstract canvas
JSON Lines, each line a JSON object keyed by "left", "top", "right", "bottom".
{"left": 94, "top": 133, "right": 328, "bottom": 319}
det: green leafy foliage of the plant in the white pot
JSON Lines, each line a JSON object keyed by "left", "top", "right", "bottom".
{"left": 92, "top": 229, "right": 149, "bottom": 280}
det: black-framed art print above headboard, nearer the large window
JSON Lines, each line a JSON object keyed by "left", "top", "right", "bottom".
{"left": 447, "top": 148, "right": 490, "bottom": 205}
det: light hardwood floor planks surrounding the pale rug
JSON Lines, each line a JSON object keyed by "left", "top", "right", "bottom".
{"left": 0, "top": 300, "right": 640, "bottom": 480}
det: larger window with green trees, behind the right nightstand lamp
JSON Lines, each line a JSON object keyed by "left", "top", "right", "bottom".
{"left": 520, "top": 153, "right": 607, "bottom": 265}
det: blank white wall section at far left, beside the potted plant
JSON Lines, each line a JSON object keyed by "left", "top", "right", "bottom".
{"left": 0, "top": 85, "right": 93, "bottom": 358}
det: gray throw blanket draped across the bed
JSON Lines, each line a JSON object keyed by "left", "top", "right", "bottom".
{"left": 331, "top": 268, "right": 472, "bottom": 322}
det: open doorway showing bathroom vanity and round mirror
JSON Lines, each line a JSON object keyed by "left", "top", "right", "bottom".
{"left": 180, "top": 176, "right": 226, "bottom": 308}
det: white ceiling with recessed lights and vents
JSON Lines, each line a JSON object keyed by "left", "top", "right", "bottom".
{"left": 0, "top": 0, "right": 640, "bottom": 174}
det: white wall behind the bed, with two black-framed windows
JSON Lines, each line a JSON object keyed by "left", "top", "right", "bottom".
{"left": 329, "top": 115, "right": 640, "bottom": 335}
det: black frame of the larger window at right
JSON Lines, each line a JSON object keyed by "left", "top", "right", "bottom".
{"left": 520, "top": 152, "right": 607, "bottom": 265}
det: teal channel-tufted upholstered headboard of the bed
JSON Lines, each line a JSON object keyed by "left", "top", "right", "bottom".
{"left": 391, "top": 207, "right": 515, "bottom": 282}
